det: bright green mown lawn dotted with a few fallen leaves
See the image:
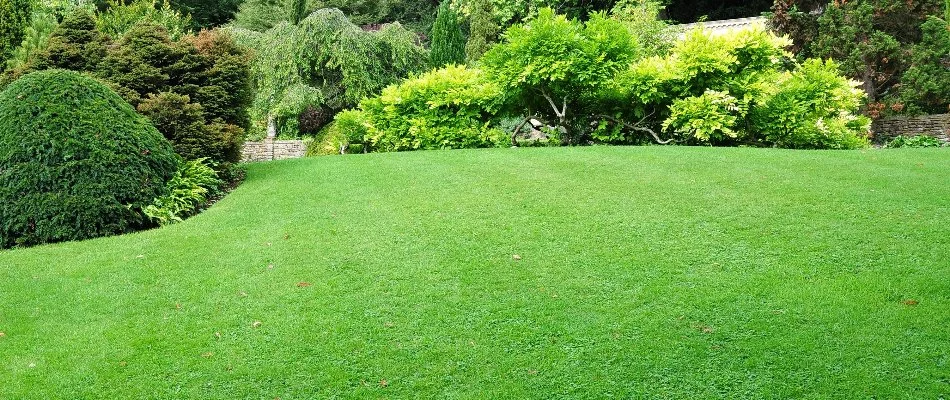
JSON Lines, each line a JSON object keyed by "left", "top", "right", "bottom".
{"left": 0, "top": 147, "right": 950, "bottom": 400}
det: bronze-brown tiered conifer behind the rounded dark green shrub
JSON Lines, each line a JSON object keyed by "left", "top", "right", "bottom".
{"left": 27, "top": 20, "right": 252, "bottom": 167}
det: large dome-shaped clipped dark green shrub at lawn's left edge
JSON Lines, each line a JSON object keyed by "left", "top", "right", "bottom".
{"left": 0, "top": 70, "right": 180, "bottom": 247}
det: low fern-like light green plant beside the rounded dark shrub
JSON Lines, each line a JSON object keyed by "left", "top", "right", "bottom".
{"left": 142, "top": 158, "right": 223, "bottom": 225}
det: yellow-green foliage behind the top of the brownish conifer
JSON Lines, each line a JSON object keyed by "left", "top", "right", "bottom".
{"left": 96, "top": 0, "right": 191, "bottom": 40}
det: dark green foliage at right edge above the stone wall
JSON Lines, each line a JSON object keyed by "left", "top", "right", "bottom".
{"left": 900, "top": 17, "right": 950, "bottom": 114}
